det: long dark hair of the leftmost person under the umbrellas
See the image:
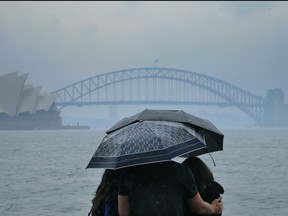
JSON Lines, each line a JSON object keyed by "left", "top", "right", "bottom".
{"left": 90, "top": 169, "right": 119, "bottom": 215}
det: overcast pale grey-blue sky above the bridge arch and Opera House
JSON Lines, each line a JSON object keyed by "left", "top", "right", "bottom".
{"left": 0, "top": 1, "right": 288, "bottom": 125}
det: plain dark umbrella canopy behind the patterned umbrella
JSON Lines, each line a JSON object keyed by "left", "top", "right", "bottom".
{"left": 106, "top": 109, "right": 224, "bottom": 157}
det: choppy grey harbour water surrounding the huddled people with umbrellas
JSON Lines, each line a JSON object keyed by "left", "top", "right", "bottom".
{"left": 0, "top": 129, "right": 288, "bottom": 216}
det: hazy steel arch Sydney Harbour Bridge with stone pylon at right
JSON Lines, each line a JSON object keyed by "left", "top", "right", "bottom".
{"left": 54, "top": 67, "right": 288, "bottom": 127}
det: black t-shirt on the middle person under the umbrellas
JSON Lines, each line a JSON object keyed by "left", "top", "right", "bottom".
{"left": 118, "top": 161, "right": 198, "bottom": 216}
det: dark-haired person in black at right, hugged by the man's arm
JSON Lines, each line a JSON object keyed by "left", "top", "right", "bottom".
{"left": 182, "top": 157, "right": 224, "bottom": 216}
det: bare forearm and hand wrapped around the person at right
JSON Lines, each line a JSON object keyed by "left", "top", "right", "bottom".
{"left": 186, "top": 193, "right": 223, "bottom": 215}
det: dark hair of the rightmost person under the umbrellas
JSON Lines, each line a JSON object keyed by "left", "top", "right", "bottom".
{"left": 182, "top": 157, "right": 214, "bottom": 194}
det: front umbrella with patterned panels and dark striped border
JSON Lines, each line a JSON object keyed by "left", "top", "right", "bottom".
{"left": 86, "top": 121, "right": 206, "bottom": 169}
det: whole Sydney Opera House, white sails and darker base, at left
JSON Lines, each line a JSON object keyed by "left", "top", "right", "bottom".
{"left": 0, "top": 72, "right": 62, "bottom": 130}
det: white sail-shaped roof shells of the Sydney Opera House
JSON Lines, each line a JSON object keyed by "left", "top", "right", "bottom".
{"left": 0, "top": 72, "right": 57, "bottom": 117}
